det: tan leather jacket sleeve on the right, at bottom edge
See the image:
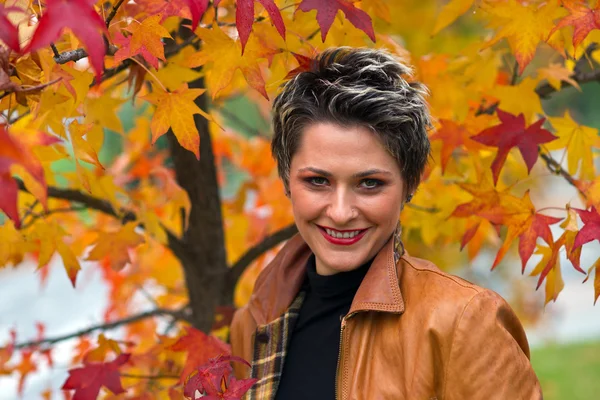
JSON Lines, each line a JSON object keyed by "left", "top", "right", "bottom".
{"left": 442, "top": 290, "right": 542, "bottom": 400}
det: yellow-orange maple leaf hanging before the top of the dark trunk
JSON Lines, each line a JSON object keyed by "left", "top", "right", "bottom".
{"left": 142, "top": 84, "right": 210, "bottom": 159}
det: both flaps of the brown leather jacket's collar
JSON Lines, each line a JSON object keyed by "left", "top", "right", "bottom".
{"left": 248, "top": 234, "right": 406, "bottom": 325}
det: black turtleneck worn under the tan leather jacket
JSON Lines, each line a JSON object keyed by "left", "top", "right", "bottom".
{"left": 276, "top": 255, "right": 372, "bottom": 400}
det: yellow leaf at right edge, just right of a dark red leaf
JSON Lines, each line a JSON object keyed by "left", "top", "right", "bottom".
{"left": 545, "top": 111, "right": 600, "bottom": 179}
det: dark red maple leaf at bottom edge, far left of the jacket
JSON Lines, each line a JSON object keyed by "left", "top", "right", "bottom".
{"left": 61, "top": 353, "right": 131, "bottom": 400}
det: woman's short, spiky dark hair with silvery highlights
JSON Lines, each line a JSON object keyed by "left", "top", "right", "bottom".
{"left": 271, "top": 47, "right": 431, "bottom": 199}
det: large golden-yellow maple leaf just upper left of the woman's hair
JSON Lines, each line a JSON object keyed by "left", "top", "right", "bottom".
{"left": 188, "top": 26, "right": 279, "bottom": 100}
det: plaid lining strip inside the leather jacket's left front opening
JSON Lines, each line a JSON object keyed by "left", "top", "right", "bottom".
{"left": 244, "top": 291, "right": 306, "bottom": 400}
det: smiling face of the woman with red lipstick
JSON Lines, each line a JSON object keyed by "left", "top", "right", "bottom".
{"left": 289, "top": 123, "right": 405, "bottom": 275}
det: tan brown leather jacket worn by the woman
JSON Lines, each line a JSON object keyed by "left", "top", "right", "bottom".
{"left": 231, "top": 235, "right": 542, "bottom": 400}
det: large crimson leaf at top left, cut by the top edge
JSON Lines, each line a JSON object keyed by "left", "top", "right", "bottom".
{"left": 23, "top": 0, "right": 108, "bottom": 82}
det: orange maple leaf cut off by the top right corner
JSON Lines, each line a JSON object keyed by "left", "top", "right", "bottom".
{"left": 548, "top": 0, "right": 600, "bottom": 48}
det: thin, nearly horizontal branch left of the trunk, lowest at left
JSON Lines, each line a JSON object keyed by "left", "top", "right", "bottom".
{"left": 14, "top": 305, "right": 188, "bottom": 349}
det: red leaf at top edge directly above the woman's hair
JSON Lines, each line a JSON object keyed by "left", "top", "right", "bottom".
{"left": 298, "top": 0, "right": 375, "bottom": 42}
